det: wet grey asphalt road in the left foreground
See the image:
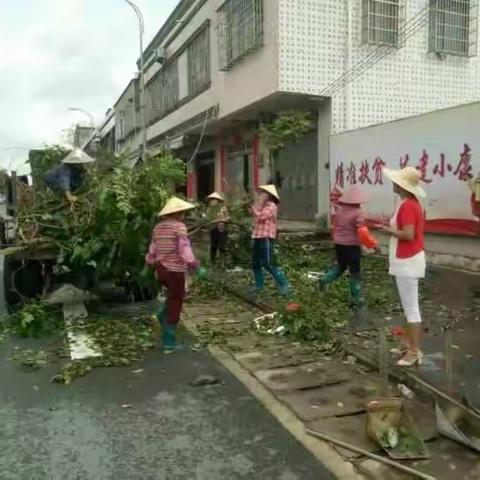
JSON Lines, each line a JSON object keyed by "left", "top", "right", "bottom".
{"left": 0, "top": 334, "right": 334, "bottom": 480}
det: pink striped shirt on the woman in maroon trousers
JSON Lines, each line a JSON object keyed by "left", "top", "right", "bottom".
{"left": 152, "top": 218, "right": 187, "bottom": 272}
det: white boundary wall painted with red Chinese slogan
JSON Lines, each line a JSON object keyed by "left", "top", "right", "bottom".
{"left": 330, "top": 102, "right": 480, "bottom": 229}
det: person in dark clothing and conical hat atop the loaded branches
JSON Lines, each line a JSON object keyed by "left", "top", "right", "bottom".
{"left": 43, "top": 148, "right": 94, "bottom": 205}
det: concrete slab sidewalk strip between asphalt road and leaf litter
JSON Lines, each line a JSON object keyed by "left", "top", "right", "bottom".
{"left": 186, "top": 292, "right": 480, "bottom": 480}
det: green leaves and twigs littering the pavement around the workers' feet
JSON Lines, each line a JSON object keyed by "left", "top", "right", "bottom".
{"left": 189, "top": 241, "right": 400, "bottom": 344}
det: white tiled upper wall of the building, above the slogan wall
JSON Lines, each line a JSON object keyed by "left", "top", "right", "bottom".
{"left": 279, "top": 0, "right": 480, "bottom": 133}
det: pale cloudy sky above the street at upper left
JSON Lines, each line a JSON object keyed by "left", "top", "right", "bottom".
{"left": 0, "top": 0, "right": 179, "bottom": 172}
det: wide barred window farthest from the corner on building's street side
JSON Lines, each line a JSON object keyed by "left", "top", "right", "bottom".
{"left": 146, "top": 59, "right": 179, "bottom": 123}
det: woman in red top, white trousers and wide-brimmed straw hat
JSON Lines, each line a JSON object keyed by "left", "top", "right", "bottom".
{"left": 383, "top": 167, "right": 426, "bottom": 367}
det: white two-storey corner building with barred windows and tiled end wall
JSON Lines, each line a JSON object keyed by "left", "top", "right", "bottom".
{"left": 115, "top": 0, "right": 480, "bottom": 219}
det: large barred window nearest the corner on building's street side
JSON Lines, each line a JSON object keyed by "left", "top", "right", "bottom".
{"left": 218, "top": 0, "right": 263, "bottom": 71}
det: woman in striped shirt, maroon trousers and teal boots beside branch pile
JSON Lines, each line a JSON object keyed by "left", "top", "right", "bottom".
{"left": 146, "top": 197, "right": 204, "bottom": 353}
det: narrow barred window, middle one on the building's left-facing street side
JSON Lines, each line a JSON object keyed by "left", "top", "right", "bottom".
{"left": 187, "top": 25, "right": 210, "bottom": 96}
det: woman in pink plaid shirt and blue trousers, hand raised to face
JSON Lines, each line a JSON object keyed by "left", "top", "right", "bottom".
{"left": 251, "top": 185, "right": 290, "bottom": 296}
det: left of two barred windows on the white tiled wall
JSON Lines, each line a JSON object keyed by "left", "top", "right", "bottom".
{"left": 362, "top": 0, "right": 404, "bottom": 45}
